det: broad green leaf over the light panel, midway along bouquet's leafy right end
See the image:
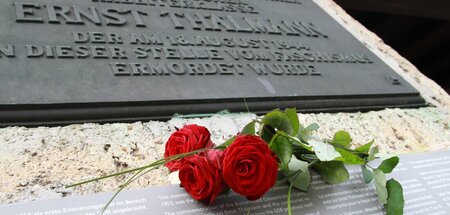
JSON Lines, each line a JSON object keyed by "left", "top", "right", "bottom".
{"left": 313, "top": 161, "right": 349, "bottom": 184}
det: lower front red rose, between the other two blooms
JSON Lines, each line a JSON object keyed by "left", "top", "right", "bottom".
{"left": 179, "top": 154, "right": 224, "bottom": 204}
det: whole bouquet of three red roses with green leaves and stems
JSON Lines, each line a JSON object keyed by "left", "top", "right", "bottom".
{"left": 69, "top": 108, "right": 404, "bottom": 215}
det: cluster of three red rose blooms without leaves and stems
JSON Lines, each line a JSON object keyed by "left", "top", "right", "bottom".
{"left": 164, "top": 125, "right": 279, "bottom": 203}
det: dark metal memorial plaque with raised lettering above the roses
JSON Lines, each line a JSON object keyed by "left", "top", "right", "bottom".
{"left": 0, "top": 0, "right": 424, "bottom": 126}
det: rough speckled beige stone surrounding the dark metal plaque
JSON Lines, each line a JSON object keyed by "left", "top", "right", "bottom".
{"left": 0, "top": 0, "right": 450, "bottom": 203}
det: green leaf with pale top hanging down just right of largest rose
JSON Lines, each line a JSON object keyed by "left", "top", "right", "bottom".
{"left": 283, "top": 156, "right": 311, "bottom": 191}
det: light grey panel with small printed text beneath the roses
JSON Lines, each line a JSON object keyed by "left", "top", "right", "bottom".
{"left": 0, "top": 151, "right": 450, "bottom": 215}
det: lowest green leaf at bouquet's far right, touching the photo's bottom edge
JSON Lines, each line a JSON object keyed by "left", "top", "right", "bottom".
{"left": 384, "top": 179, "right": 405, "bottom": 215}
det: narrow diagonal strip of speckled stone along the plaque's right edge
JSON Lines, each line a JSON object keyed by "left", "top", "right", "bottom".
{"left": 313, "top": 0, "right": 450, "bottom": 111}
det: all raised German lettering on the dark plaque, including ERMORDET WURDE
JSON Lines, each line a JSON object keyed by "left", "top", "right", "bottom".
{"left": 0, "top": 0, "right": 373, "bottom": 76}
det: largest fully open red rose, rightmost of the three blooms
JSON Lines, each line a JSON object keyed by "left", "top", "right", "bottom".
{"left": 222, "top": 135, "right": 278, "bottom": 200}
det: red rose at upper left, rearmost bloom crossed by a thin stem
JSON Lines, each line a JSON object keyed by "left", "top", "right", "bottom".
{"left": 164, "top": 124, "right": 213, "bottom": 171}
